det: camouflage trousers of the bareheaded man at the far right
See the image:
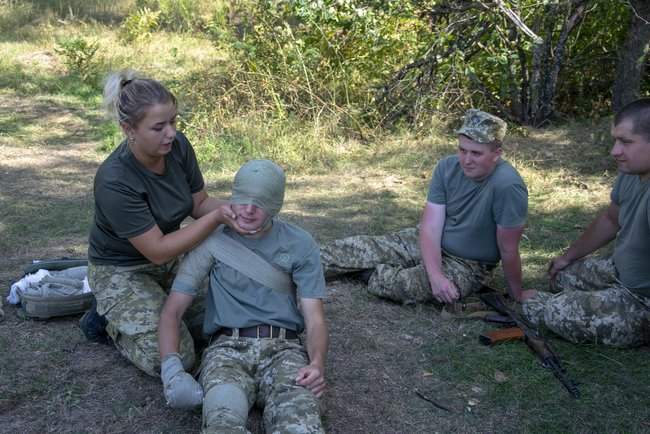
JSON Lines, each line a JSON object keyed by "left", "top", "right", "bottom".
{"left": 522, "top": 257, "right": 650, "bottom": 347}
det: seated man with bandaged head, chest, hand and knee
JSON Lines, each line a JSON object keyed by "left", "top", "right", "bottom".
{"left": 158, "top": 160, "right": 329, "bottom": 433}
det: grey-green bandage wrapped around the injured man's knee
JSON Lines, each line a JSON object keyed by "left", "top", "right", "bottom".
{"left": 203, "top": 384, "right": 248, "bottom": 426}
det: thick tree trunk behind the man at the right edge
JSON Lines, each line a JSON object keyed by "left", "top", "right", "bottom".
{"left": 612, "top": 0, "right": 650, "bottom": 111}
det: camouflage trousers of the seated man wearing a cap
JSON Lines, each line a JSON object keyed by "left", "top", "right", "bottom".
{"left": 321, "top": 228, "right": 494, "bottom": 303}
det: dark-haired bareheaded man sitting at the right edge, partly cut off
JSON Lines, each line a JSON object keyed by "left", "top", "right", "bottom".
{"left": 522, "top": 99, "right": 650, "bottom": 347}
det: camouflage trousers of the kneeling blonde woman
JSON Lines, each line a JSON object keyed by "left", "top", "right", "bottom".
{"left": 88, "top": 261, "right": 205, "bottom": 377}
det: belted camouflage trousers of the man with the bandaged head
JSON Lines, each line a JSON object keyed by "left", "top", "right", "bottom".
{"left": 199, "top": 336, "right": 324, "bottom": 434}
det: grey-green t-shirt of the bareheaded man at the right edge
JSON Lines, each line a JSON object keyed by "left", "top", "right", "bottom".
{"left": 611, "top": 173, "right": 650, "bottom": 297}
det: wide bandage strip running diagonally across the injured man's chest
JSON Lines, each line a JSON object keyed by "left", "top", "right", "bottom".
{"left": 212, "top": 229, "right": 296, "bottom": 298}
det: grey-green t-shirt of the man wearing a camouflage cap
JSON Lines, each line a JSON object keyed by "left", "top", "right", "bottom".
{"left": 427, "top": 155, "right": 528, "bottom": 264}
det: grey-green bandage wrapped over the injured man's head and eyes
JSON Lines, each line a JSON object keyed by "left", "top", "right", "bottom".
{"left": 230, "top": 160, "right": 285, "bottom": 217}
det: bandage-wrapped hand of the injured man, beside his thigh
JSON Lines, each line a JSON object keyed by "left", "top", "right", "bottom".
{"left": 160, "top": 353, "right": 203, "bottom": 409}
